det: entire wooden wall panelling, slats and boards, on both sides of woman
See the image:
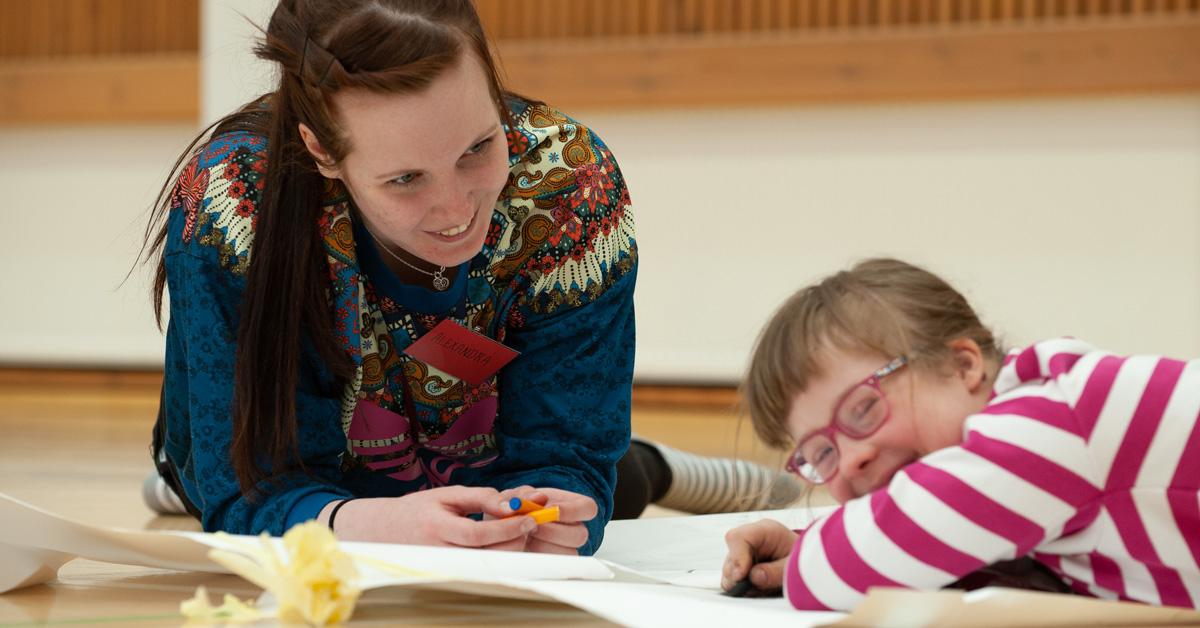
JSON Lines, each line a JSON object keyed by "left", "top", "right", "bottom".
{"left": 0, "top": 0, "right": 1200, "bottom": 125}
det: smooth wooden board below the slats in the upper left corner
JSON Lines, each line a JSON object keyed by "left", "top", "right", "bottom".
{"left": 0, "top": 53, "right": 200, "bottom": 125}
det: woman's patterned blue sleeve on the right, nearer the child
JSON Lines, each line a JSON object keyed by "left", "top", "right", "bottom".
{"left": 475, "top": 106, "right": 637, "bottom": 555}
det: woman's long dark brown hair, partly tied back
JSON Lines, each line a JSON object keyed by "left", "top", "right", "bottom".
{"left": 142, "top": 0, "right": 511, "bottom": 497}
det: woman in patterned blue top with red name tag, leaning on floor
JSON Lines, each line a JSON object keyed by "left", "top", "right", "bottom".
{"left": 142, "top": 0, "right": 796, "bottom": 554}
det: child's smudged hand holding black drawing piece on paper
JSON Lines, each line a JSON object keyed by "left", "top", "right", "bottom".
{"left": 721, "top": 519, "right": 798, "bottom": 591}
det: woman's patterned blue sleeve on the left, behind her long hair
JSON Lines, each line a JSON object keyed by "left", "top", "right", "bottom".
{"left": 163, "top": 136, "right": 349, "bottom": 534}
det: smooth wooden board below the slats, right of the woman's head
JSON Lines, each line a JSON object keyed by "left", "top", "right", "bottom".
{"left": 498, "top": 18, "right": 1200, "bottom": 110}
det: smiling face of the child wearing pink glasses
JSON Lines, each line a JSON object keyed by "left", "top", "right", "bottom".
{"left": 787, "top": 341, "right": 991, "bottom": 502}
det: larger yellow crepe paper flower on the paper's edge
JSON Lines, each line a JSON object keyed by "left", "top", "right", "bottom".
{"left": 185, "top": 521, "right": 362, "bottom": 626}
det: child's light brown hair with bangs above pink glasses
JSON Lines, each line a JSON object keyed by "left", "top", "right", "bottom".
{"left": 742, "top": 258, "right": 1003, "bottom": 448}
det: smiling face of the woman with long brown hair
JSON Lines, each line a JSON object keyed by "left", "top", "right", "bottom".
{"left": 301, "top": 53, "right": 509, "bottom": 267}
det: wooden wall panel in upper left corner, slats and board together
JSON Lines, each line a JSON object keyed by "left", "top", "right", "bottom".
{"left": 0, "top": 0, "right": 199, "bottom": 125}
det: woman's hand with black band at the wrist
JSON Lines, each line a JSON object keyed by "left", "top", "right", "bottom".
{"left": 318, "top": 486, "right": 538, "bottom": 551}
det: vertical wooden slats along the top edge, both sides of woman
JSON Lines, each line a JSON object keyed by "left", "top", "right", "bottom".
{"left": 0, "top": 0, "right": 1200, "bottom": 54}
